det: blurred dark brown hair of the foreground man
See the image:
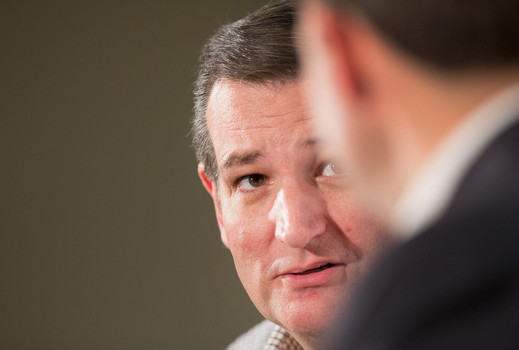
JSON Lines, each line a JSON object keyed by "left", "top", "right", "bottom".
{"left": 326, "top": 0, "right": 519, "bottom": 71}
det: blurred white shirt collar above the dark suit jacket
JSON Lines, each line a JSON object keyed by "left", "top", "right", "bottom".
{"left": 390, "top": 83, "right": 519, "bottom": 241}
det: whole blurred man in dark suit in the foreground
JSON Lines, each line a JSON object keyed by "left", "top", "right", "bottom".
{"left": 301, "top": 0, "right": 519, "bottom": 350}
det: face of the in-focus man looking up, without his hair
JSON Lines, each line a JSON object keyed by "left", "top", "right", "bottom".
{"left": 201, "top": 81, "right": 383, "bottom": 335}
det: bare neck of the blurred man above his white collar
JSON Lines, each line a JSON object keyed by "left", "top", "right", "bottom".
{"left": 383, "top": 67, "right": 519, "bottom": 217}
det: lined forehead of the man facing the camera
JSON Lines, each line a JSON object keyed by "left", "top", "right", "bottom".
{"left": 207, "top": 81, "right": 315, "bottom": 156}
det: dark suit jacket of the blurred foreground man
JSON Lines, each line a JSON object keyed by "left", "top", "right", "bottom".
{"left": 335, "top": 119, "right": 519, "bottom": 350}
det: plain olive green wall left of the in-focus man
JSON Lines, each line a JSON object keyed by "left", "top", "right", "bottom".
{"left": 0, "top": 0, "right": 267, "bottom": 350}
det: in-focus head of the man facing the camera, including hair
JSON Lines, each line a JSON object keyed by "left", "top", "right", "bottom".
{"left": 193, "top": 1, "right": 384, "bottom": 349}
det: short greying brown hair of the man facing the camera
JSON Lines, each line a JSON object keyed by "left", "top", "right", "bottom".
{"left": 192, "top": 0, "right": 299, "bottom": 180}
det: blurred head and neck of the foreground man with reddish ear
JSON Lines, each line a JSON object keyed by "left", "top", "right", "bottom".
{"left": 301, "top": 0, "right": 519, "bottom": 220}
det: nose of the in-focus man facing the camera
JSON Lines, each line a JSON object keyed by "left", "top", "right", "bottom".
{"left": 268, "top": 186, "right": 326, "bottom": 248}
